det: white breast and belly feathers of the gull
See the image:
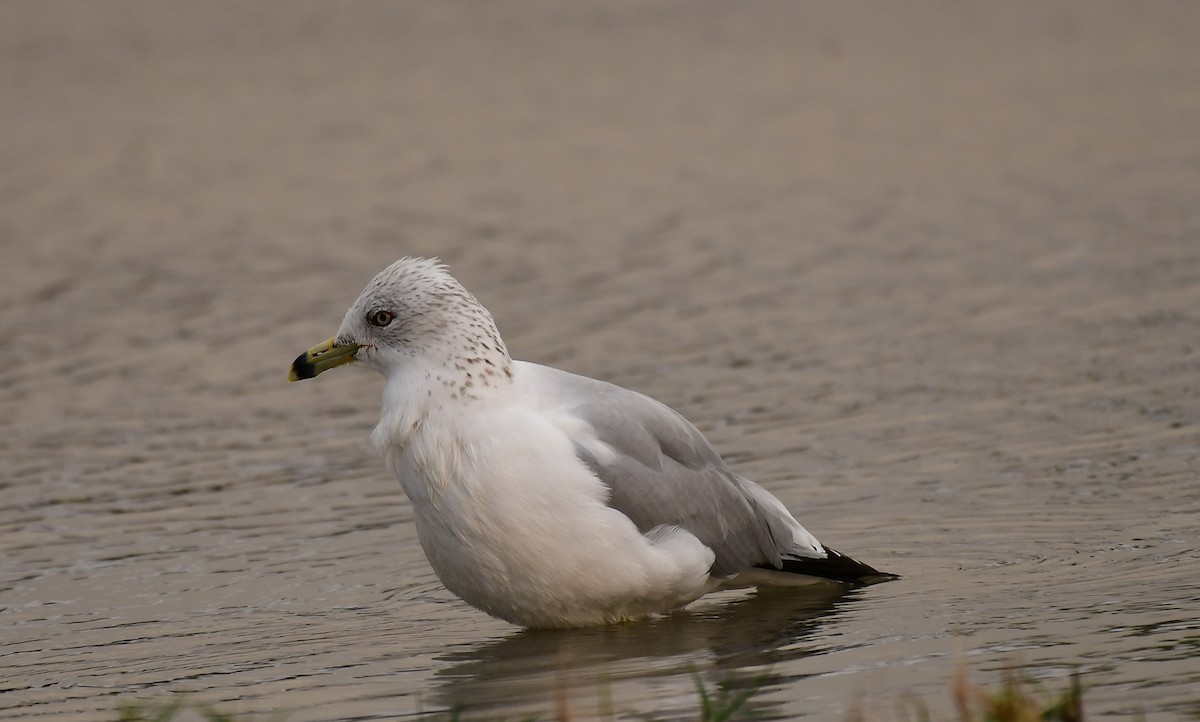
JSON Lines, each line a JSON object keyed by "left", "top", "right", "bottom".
{"left": 377, "top": 407, "right": 713, "bottom": 626}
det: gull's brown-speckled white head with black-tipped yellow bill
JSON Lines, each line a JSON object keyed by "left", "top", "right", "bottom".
{"left": 288, "top": 258, "right": 510, "bottom": 381}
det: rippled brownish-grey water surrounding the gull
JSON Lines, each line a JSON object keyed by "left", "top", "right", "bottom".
{"left": 0, "top": 2, "right": 1200, "bottom": 721}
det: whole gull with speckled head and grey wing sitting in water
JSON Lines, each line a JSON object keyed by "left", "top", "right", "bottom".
{"left": 288, "top": 258, "right": 895, "bottom": 627}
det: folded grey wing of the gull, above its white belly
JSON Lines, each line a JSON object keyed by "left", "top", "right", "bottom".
{"left": 528, "top": 367, "right": 794, "bottom": 577}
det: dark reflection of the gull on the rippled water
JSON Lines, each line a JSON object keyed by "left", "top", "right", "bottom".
{"left": 434, "top": 583, "right": 857, "bottom": 715}
